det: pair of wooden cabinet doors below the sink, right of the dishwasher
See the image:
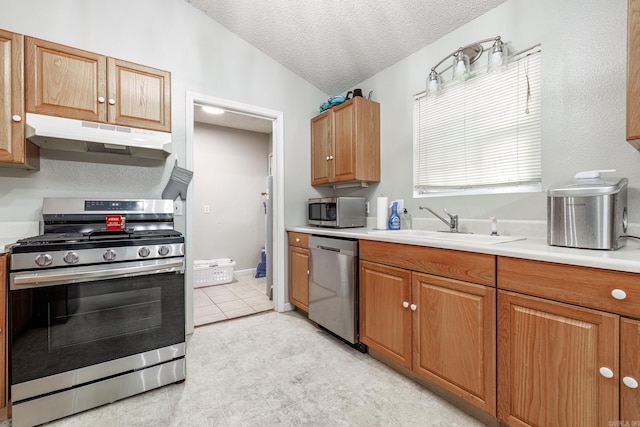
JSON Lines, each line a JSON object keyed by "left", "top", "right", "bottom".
{"left": 360, "top": 261, "right": 496, "bottom": 416}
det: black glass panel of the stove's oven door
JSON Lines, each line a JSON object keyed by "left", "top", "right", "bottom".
{"left": 11, "top": 273, "right": 185, "bottom": 384}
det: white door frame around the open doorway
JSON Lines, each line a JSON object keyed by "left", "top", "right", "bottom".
{"left": 185, "top": 91, "right": 284, "bottom": 333}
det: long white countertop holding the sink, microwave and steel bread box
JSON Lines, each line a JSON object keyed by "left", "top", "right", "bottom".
{"left": 287, "top": 226, "right": 640, "bottom": 273}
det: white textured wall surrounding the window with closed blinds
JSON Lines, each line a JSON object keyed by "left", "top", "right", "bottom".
{"left": 352, "top": 0, "right": 640, "bottom": 224}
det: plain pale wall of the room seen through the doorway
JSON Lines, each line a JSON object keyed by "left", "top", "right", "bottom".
{"left": 192, "top": 123, "right": 271, "bottom": 270}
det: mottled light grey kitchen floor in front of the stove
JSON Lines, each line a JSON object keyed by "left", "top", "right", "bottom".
{"left": 33, "top": 311, "right": 483, "bottom": 427}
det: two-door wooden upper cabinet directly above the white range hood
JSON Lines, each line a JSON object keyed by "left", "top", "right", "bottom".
{"left": 25, "top": 37, "right": 171, "bottom": 132}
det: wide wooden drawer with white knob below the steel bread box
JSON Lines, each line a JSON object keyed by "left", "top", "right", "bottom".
{"left": 498, "top": 257, "right": 640, "bottom": 318}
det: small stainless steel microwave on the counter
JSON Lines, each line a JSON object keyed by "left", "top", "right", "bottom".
{"left": 307, "top": 197, "right": 367, "bottom": 228}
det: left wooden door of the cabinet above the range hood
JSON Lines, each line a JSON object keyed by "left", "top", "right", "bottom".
{"left": 25, "top": 37, "right": 107, "bottom": 122}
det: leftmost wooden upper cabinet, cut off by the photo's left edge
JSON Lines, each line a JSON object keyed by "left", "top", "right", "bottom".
{"left": 0, "top": 30, "right": 40, "bottom": 169}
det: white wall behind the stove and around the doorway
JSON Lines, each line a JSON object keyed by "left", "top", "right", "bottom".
{"left": 0, "top": 0, "right": 327, "bottom": 227}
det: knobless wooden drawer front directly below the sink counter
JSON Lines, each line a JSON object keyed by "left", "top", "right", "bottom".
{"left": 359, "top": 240, "right": 496, "bottom": 286}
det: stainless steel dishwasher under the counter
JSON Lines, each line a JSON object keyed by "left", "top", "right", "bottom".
{"left": 309, "top": 236, "right": 366, "bottom": 352}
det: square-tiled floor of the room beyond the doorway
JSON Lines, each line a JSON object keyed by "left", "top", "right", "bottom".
{"left": 193, "top": 270, "right": 273, "bottom": 326}
